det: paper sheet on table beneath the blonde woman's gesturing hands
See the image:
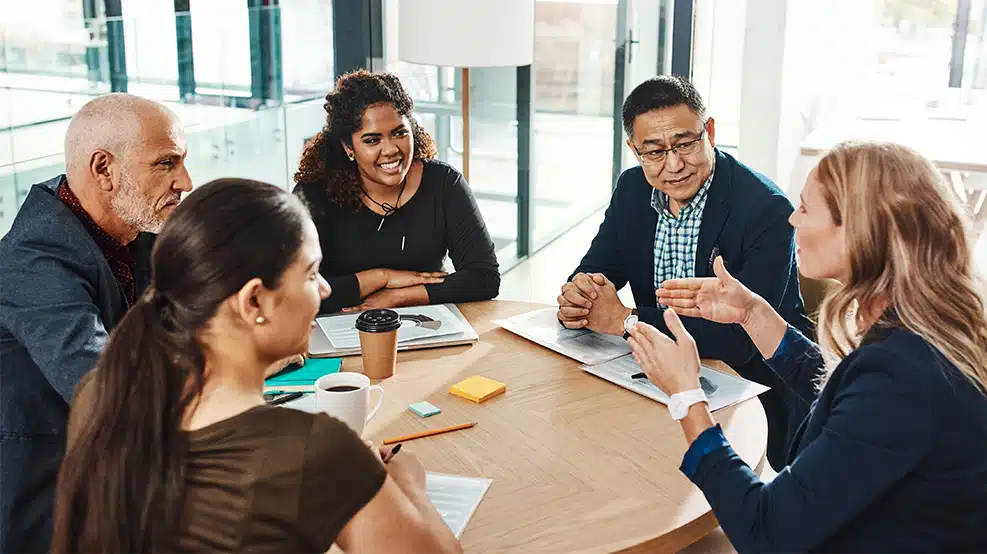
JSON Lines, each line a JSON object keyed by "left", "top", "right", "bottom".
{"left": 583, "top": 356, "right": 768, "bottom": 411}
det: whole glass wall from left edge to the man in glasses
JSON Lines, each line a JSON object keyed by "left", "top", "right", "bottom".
{"left": 0, "top": 0, "right": 691, "bottom": 270}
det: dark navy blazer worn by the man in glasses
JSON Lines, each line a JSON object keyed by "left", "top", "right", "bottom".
{"left": 570, "top": 150, "right": 810, "bottom": 467}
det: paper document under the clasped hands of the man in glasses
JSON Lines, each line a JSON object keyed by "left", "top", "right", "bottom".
{"left": 494, "top": 308, "right": 631, "bottom": 365}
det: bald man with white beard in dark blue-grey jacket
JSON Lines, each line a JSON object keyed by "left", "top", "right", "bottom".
{"left": 0, "top": 94, "right": 192, "bottom": 552}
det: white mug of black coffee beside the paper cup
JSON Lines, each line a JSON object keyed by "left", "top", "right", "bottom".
{"left": 315, "top": 371, "right": 384, "bottom": 436}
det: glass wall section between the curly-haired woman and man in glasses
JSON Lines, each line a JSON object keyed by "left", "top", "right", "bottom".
{"left": 378, "top": 0, "right": 691, "bottom": 266}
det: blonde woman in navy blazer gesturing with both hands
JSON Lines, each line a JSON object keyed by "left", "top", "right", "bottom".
{"left": 629, "top": 143, "right": 987, "bottom": 552}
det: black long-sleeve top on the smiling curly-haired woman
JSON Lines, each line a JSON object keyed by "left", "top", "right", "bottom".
{"left": 294, "top": 160, "right": 500, "bottom": 313}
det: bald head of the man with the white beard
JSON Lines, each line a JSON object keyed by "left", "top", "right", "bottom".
{"left": 65, "top": 93, "right": 192, "bottom": 240}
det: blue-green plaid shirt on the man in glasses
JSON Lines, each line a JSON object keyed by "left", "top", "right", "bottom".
{"left": 651, "top": 166, "right": 716, "bottom": 290}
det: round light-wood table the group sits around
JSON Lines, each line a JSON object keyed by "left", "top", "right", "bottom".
{"left": 343, "top": 301, "right": 767, "bottom": 553}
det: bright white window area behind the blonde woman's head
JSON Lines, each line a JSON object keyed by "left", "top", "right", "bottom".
{"left": 693, "top": 0, "right": 987, "bottom": 268}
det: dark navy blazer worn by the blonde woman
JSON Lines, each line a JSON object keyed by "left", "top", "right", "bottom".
{"left": 693, "top": 327, "right": 987, "bottom": 552}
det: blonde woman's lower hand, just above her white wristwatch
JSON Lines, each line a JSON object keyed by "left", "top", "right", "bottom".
{"left": 627, "top": 309, "right": 700, "bottom": 396}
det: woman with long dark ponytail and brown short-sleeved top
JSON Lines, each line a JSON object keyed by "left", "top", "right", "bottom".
{"left": 52, "top": 179, "right": 460, "bottom": 553}
